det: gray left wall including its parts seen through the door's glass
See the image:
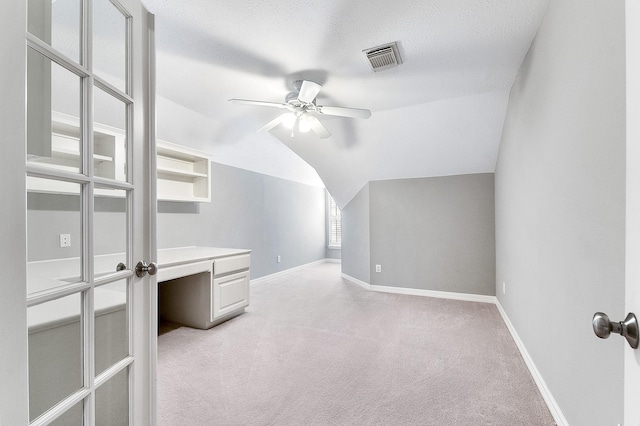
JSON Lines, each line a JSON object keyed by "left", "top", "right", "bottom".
{"left": 27, "top": 163, "right": 327, "bottom": 278}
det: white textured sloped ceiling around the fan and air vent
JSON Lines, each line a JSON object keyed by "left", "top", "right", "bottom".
{"left": 143, "top": 0, "right": 549, "bottom": 207}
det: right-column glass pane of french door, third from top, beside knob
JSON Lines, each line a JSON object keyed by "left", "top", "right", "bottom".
{"left": 93, "top": 187, "right": 131, "bottom": 277}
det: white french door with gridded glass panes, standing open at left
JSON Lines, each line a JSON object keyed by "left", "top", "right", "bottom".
{"left": 0, "top": 0, "right": 156, "bottom": 425}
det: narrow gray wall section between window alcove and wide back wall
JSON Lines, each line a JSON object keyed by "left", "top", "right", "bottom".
{"left": 341, "top": 184, "right": 371, "bottom": 284}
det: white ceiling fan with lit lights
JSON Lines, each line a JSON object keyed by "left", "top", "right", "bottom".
{"left": 229, "top": 80, "right": 371, "bottom": 139}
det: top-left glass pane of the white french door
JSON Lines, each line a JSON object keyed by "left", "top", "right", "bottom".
{"left": 27, "top": 0, "right": 81, "bottom": 62}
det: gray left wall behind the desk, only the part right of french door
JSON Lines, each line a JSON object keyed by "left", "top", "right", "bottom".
{"left": 158, "top": 163, "right": 326, "bottom": 279}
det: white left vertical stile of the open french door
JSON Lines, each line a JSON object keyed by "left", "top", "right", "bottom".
{"left": 0, "top": 1, "right": 29, "bottom": 426}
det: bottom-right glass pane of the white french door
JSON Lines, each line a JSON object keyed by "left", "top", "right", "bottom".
{"left": 96, "top": 368, "right": 129, "bottom": 426}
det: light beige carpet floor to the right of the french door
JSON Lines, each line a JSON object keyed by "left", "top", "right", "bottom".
{"left": 158, "top": 263, "right": 555, "bottom": 426}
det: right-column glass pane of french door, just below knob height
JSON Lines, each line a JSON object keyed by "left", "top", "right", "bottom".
{"left": 94, "top": 280, "right": 129, "bottom": 375}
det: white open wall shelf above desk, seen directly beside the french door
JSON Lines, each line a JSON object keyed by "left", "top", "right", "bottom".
{"left": 157, "top": 141, "right": 211, "bottom": 203}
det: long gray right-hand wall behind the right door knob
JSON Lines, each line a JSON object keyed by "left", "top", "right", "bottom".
{"left": 496, "top": 0, "right": 626, "bottom": 426}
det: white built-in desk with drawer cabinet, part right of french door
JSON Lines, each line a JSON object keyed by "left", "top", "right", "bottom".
{"left": 158, "top": 247, "right": 251, "bottom": 329}
